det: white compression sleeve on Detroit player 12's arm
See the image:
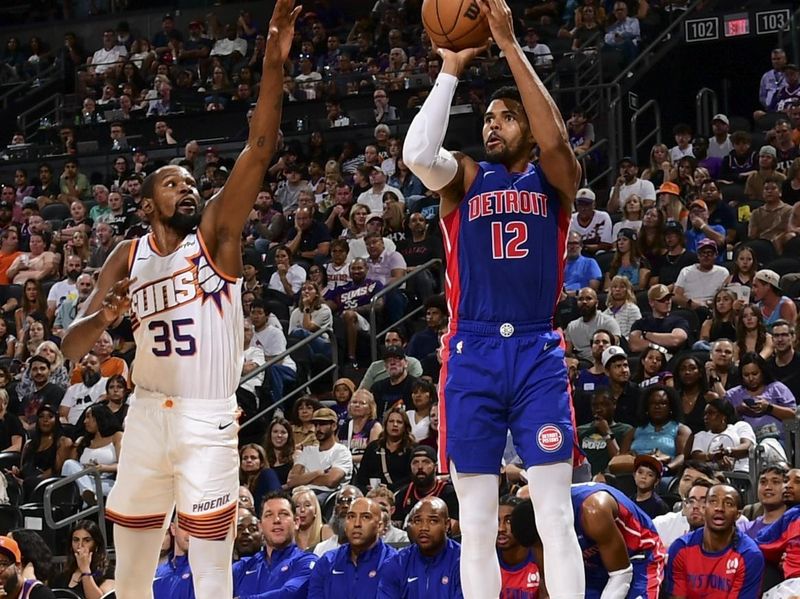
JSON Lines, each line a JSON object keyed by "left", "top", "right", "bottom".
{"left": 403, "top": 73, "right": 458, "bottom": 191}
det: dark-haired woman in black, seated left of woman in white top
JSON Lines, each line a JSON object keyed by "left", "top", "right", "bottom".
{"left": 12, "top": 404, "right": 72, "bottom": 497}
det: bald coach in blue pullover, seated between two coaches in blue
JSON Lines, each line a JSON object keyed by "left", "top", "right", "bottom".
{"left": 308, "top": 497, "right": 397, "bottom": 599}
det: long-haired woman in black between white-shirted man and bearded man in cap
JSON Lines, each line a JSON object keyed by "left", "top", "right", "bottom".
{"left": 356, "top": 407, "right": 415, "bottom": 493}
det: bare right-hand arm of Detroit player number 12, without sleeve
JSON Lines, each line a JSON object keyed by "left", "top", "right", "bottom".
{"left": 477, "top": 0, "right": 581, "bottom": 211}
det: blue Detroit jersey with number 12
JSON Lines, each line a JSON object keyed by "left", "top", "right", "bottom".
{"left": 442, "top": 162, "right": 570, "bottom": 323}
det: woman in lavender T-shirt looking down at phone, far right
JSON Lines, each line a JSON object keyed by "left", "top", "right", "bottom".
{"left": 725, "top": 352, "right": 797, "bottom": 452}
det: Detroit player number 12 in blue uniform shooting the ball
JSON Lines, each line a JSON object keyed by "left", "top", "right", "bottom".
{"left": 403, "top": 0, "right": 585, "bottom": 599}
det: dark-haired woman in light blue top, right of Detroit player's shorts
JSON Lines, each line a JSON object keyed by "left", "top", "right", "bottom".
{"left": 620, "top": 385, "right": 692, "bottom": 475}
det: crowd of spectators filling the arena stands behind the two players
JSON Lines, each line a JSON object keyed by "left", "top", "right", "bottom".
{"left": 0, "top": 0, "right": 800, "bottom": 597}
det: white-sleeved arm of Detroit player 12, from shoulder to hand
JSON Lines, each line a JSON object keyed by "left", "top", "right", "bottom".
{"left": 403, "top": 47, "right": 485, "bottom": 216}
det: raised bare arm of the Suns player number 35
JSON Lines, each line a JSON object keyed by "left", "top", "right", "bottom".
{"left": 200, "top": 0, "right": 302, "bottom": 245}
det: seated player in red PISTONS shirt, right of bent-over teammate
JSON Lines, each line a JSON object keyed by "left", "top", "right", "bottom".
{"left": 665, "top": 484, "right": 764, "bottom": 597}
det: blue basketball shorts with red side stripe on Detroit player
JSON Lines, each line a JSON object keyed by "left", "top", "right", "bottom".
{"left": 439, "top": 321, "right": 577, "bottom": 474}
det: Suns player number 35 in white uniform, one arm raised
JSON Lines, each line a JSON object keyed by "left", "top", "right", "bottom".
{"left": 63, "top": 0, "right": 301, "bottom": 599}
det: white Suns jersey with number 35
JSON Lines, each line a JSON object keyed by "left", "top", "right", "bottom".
{"left": 128, "top": 232, "right": 244, "bottom": 399}
